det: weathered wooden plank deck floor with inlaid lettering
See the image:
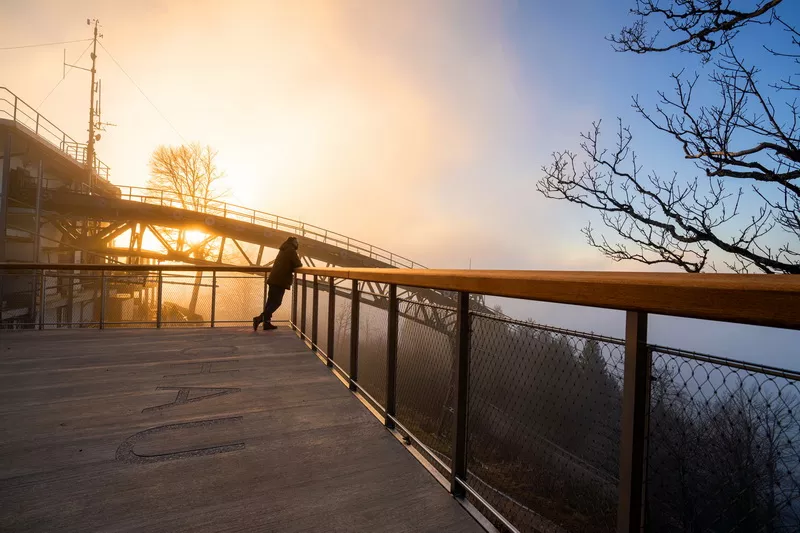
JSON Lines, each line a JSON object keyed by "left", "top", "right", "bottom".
{"left": 0, "top": 328, "right": 482, "bottom": 532}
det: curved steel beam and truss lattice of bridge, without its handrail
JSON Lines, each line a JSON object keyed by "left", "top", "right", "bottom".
{"left": 32, "top": 187, "right": 491, "bottom": 333}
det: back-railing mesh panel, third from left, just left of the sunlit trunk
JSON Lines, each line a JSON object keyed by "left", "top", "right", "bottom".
{"left": 104, "top": 272, "right": 158, "bottom": 328}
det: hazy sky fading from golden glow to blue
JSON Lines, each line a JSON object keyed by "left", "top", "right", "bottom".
{"left": 0, "top": 0, "right": 797, "bottom": 366}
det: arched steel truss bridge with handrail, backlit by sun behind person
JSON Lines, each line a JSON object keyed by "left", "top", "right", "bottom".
{"left": 10, "top": 183, "right": 491, "bottom": 332}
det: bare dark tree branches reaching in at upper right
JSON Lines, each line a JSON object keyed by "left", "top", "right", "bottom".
{"left": 537, "top": 0, "right": 800, "bottom": 273}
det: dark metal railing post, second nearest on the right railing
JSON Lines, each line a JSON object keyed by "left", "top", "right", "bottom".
{"left": 450, "top": 291, "right": 470, "bottom": 498}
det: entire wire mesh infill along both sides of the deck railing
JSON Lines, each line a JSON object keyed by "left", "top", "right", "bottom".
{"left": 7, "top": 268, "right": 800, "bottom": 533}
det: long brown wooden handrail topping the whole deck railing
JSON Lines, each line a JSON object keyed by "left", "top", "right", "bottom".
{"left": 0, "top": 263, "right": 800, "bottom": 329}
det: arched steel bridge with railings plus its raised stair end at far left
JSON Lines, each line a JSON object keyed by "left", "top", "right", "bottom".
{"left": 0, "top": 88, "right": 491, "bottom": 331}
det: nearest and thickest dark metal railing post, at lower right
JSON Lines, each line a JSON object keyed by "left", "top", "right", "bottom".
{"left": 617, "top": 311, "right": 651, "bottom": 533}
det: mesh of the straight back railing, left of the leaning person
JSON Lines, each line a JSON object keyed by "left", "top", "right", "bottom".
{"left": 0, "top": 269, "right": 282, "bottom": 329}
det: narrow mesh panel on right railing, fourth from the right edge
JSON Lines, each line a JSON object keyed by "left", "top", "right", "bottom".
{"left": 358, "top": 283, "right": 389, "bottom": 407}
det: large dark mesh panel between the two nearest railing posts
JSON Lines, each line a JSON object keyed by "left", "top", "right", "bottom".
{"left": 467, "top": 314, "right": 624, "bottom": 532}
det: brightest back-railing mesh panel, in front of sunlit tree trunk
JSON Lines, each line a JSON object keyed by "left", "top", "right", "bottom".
{"left": 161, "top": 271, "right": 213, "bottom": 327}
